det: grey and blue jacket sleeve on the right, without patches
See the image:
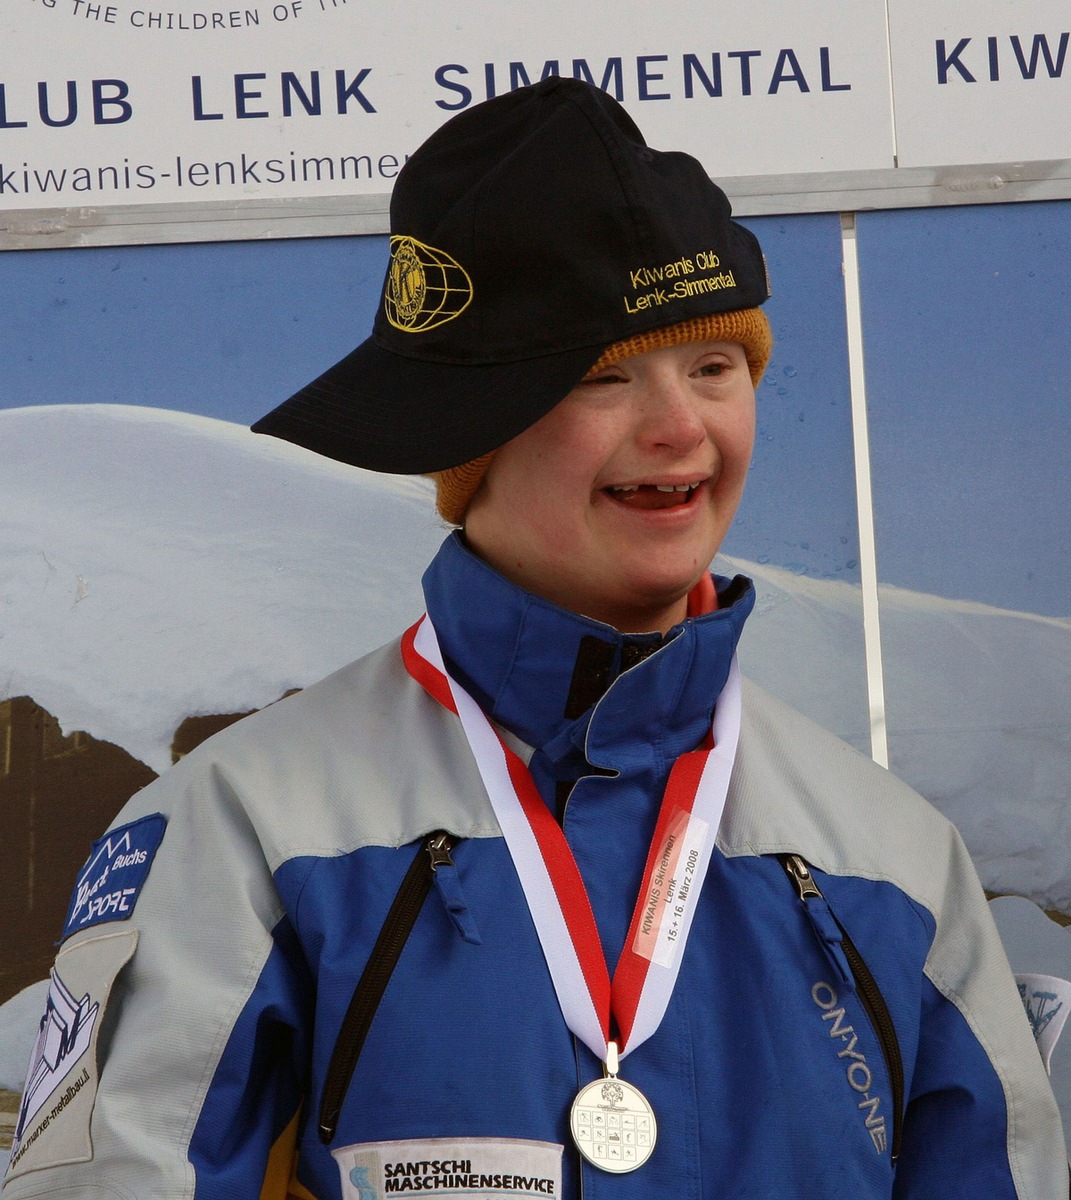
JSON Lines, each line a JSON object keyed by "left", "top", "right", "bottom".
{"left": 895, "top": 828, "right": 1069, "bottom": 1200}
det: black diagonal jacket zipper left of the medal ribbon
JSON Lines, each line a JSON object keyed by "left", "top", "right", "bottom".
{"left": 317, "top": 829, "right": 456, "bottom": 1145}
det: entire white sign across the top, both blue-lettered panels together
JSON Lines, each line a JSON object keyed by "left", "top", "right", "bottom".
{"left": 0, "top": 0, "right": 1071, "bottom": 226}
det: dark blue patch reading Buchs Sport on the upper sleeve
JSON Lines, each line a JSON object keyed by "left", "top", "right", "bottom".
{"left": 60, "top": 812, "right": 167, "bottom": 941}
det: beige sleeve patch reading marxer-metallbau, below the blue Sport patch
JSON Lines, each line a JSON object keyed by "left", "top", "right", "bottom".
{"left": 7, "top": 929, "right": 138, "bottom": 1178}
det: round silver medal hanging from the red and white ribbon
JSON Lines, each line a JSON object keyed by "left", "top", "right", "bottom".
{"left": 569, "top": 1042, "right": 658, "bottom": 1175}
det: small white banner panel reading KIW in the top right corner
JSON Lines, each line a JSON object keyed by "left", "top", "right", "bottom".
{"left": 888, "top": 0, "right": 1071, "bottom": 167}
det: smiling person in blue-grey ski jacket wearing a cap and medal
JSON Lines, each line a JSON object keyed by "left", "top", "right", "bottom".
{"left": 4, "top": 79, "right": 1067, "bottom": 1200}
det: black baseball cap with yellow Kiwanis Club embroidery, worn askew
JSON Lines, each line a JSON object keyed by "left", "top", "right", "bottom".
{"left": 252, "top": 77, "right": 770, "bottom": 474}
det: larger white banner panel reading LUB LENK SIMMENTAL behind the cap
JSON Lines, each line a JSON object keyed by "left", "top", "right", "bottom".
{"left": 0, "top": 0, "right": 893, "bottom": 210}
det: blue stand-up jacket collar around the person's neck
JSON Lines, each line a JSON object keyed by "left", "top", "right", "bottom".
{"left": 424, "top": 533, "right": 754, "bottom": 778}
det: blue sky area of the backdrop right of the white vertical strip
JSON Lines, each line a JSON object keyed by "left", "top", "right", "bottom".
{"left": 858, "top": 200, "right": 1071, "bottom": 617}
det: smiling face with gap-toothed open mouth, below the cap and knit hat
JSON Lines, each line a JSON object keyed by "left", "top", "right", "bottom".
{"left": 465, "top": 342, "right": 755, "bottom": 632}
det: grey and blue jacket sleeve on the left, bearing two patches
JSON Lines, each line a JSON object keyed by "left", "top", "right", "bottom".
{"left": 4, "top": 746, "right": 311, "bottom": 1200}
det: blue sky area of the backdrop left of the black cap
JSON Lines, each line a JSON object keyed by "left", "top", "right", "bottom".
{"left": 0, "top": 236, "right": 387, "bottom": 425}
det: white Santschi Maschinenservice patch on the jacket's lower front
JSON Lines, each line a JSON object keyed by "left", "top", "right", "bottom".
{"left": 331, "top": 1138, "right": 562, "bottom": 1200}
